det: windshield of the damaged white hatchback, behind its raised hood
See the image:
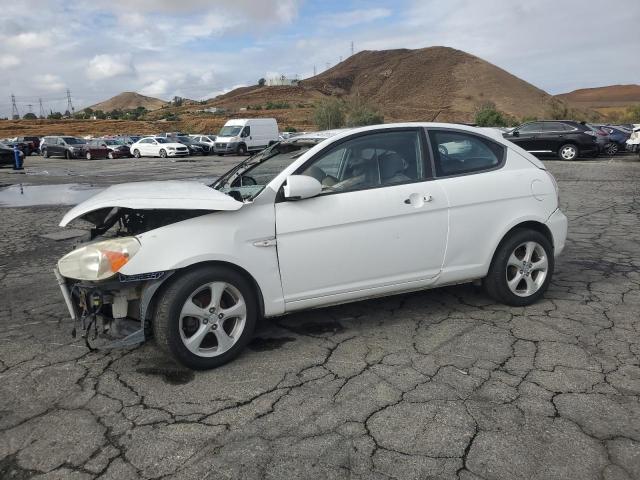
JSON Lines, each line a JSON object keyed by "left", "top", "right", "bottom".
{"left": 211, "top": 143, "right": 313, "bottom": 201}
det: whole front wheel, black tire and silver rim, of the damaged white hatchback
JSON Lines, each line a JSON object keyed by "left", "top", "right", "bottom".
{"left": 154, "top": 267, "right": 258, "bottom": 370}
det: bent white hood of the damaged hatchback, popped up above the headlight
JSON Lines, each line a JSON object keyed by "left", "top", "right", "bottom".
{"left": 60, "top": 181, "right": 243, "bottom": 227}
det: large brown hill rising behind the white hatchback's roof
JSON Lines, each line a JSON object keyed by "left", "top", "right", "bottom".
{"left": 209, "top": 47, "right": 564, "bottom": 122}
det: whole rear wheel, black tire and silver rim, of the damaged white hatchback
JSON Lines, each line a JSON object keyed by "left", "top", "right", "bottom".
{"left": 483, "top": 229, "right": 555, "bottom": 307}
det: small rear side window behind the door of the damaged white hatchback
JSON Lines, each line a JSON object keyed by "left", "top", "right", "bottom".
{"left": 429, "top": 130, "right": 505, "bottom": 177}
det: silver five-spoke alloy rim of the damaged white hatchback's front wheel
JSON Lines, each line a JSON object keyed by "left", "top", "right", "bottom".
{"left": 178, "top": 282, "right": 247, "bottom": 357}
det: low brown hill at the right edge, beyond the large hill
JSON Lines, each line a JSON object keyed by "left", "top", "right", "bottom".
{"left": 556, "top": 85, "right": 640, "bottom": 113}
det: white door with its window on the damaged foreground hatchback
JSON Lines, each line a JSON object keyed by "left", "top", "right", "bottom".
{"left": 276, "top": 129, "right": 448, "bottom": 310}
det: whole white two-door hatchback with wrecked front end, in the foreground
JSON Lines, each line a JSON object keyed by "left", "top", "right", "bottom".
{"left": 56, "top": 123, "right": 567, "bottom": 369}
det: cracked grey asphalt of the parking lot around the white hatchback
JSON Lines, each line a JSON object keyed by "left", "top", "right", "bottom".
{"left": 0, "top": 157, "right": 640, "bottom": 480}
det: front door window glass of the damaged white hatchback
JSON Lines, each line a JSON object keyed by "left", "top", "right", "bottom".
{"left": 297, "top": 130, "right": 425, "bottom": 194}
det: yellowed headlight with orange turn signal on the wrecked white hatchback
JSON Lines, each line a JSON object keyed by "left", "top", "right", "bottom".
{"left": 58, "top": 237, "right": 140, "bottom": 280}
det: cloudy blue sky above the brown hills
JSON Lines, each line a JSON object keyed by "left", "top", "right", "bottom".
{"left": 0, "top": 0, "right": 640, "bottom": 116}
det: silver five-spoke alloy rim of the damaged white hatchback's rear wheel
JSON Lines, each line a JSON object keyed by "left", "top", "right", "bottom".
{"left": 505, "top": 241, "right": 549, "bottom": 297}
